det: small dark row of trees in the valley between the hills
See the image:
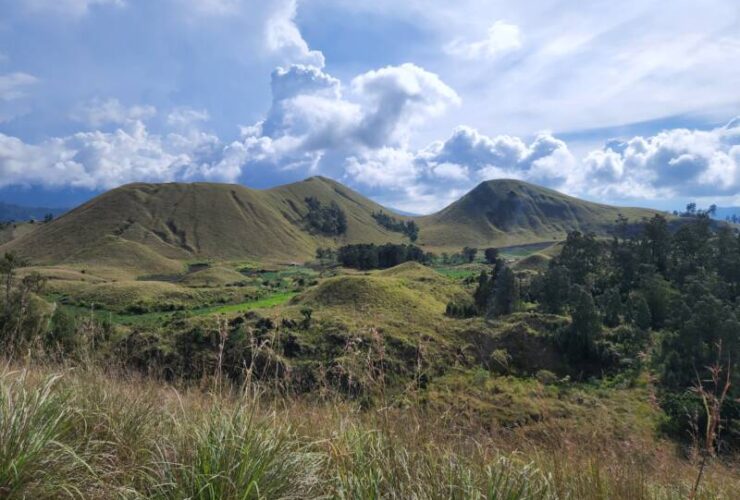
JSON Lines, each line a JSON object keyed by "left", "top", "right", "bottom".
{"left": 337, "top": 243, "right": 433, "bottom": 269}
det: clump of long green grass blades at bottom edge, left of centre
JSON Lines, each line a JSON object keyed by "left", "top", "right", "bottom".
{"left": 152, "top": 407, "right": 323, "bottom": 500}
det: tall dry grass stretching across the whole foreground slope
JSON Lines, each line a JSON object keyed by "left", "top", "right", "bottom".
{"left": 0, "top": 363, "right": 740, "bottom": 500}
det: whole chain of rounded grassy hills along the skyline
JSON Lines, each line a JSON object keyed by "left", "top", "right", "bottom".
{"left": 0, "top": 177, "right": 668, "bottom": 273}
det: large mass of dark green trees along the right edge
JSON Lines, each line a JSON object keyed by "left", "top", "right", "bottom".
{"left": 528, "top": 217, "right": 740, "bottom": 439}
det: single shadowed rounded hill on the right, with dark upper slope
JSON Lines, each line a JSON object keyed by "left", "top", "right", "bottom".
{"left": 417, "top": 179, "right": 658, "bottom": 249}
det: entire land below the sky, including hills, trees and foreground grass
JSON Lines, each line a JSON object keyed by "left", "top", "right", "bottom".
{"left": 0, "top": 178, "right": 740, "bottom": 499}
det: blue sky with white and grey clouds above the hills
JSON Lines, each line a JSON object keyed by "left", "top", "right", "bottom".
{"left": 0, "top": 0, "right": 740, "bottom": 213}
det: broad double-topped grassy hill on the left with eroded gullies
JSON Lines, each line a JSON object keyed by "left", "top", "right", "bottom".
{"left": 3, "top": 177, "right": 403, "bottom": 272}
